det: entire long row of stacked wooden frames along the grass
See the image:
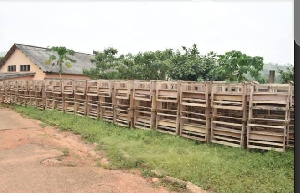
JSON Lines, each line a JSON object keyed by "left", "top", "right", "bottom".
{"left": 0, "top": 79, "right": 295, "bottom": 151}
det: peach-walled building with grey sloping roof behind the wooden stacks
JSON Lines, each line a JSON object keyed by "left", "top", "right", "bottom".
{"left": 0, "top": 44, "right": 96, "bottom": 80}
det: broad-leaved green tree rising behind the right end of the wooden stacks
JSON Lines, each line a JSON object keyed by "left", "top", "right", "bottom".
{"left": 212, "top": 50, "right": 264, "bottom": 82}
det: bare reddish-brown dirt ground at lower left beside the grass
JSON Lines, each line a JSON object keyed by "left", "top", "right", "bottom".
{"left": 0, "top": 107, "right": 176, "bottom": 193}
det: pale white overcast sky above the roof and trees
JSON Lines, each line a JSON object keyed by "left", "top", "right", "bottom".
{"left": 0, "top": 0, "right": 294, "bottom": 65}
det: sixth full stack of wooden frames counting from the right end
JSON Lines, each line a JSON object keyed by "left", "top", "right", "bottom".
{"left": 112, "top": 80, "right": 133, "bottom": 127}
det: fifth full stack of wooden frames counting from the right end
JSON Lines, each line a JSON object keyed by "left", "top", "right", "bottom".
{"left": 133, "top": 81, "right": 156, "bottom": 130}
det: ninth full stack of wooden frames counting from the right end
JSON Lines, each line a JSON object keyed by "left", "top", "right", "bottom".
{"left": 74, "top": 80, "right": 87, "bottom": 116}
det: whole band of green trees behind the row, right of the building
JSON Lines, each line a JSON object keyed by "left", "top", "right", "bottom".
{"left": 84, "top": 44, "right": 265, "bottom": 82}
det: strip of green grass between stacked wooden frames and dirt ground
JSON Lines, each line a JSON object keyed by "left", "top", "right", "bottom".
{"left": 15, "top": 106, "right": 294, "bottom": 192}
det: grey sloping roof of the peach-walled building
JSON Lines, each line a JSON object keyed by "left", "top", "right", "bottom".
{"left": 15, "top": 44, "right": 96, "bottom": 74}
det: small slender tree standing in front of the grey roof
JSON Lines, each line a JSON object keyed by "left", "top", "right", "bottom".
{"left": 46, "top": 47, "right": 76, "bottom": 78}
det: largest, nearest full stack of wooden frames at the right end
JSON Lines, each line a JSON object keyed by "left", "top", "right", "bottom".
{"left": 247, "top": 84, "right": 290, "bottom": 151}
